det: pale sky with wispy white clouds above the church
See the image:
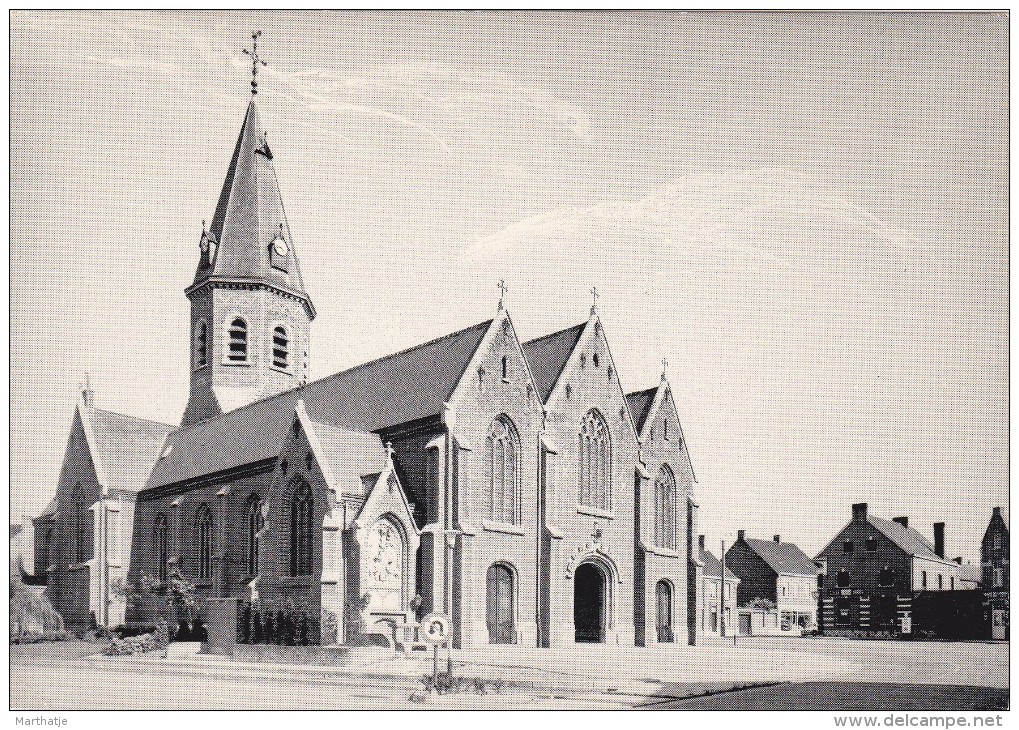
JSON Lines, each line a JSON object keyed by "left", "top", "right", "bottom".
{"left": 10, "top": 11, "right": 1008, "bottom": 561}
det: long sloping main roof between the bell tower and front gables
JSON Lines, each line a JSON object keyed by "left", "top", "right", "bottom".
{"left": 149, "top": 320, "right": 491, "bottom": 487}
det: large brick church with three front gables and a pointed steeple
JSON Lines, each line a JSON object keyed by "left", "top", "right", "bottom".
{"left": 31, "top": 68, "right": 702, "bottom": 647}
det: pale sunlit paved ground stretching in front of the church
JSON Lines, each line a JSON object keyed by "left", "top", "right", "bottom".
{"left": 10, "top": 638, "right": 1008, "bottom": 710}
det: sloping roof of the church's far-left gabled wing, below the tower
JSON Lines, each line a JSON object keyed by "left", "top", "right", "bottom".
{"left": 89, "top": 408, "right": 173, "bottom": 491}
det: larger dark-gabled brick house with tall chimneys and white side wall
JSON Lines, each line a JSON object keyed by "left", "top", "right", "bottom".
{"left": 817, "top": 503, "right": 964, "bottom": 631}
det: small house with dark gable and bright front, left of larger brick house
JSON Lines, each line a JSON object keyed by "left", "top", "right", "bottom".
{"left": 726, "top": 530, "right": 820, "bottom": 630}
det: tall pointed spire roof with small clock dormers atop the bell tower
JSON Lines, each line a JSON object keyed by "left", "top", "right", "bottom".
{"left": 195, "top": 99, "right": 310, "bottom": 309}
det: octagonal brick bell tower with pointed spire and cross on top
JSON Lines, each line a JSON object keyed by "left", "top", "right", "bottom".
{"left": 180, "top": 34, "right": 315, "bottom": 426}
